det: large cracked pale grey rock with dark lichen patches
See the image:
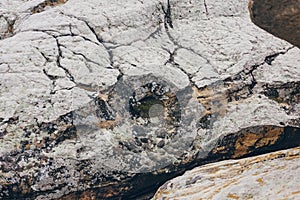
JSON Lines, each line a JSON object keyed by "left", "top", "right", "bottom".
{"left": 0, "top": 0, "right": 300, "bottom": 199}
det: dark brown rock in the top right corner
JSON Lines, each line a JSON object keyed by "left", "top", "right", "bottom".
{"left": 249, "top": 0, "right": 300, "bottom": 47}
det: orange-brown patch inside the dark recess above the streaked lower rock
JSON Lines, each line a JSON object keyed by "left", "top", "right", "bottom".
{"left": 233, "top": 126, "right": 284, "bottom": 158}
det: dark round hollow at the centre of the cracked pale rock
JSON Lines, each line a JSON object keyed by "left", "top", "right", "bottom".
{"left": 129, "top": 81, "right": 181, "bottom": 129}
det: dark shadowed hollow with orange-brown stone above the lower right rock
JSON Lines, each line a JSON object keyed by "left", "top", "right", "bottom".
{"left": 208, "top": 125, "right": 299, "bottom": 161}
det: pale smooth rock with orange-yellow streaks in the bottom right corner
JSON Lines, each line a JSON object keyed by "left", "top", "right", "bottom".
{"left": 153, "top": 147, "right": 300, "bottom": 200}
